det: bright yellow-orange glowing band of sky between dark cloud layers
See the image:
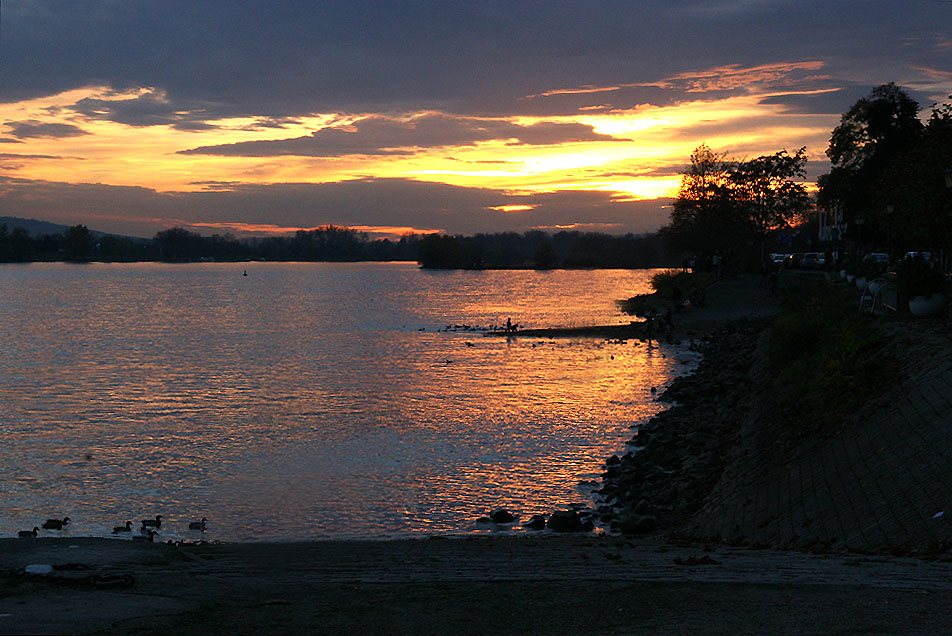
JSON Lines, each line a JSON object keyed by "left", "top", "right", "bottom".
{"left": 0, "top": 79, "right": 835, "bottom": 234}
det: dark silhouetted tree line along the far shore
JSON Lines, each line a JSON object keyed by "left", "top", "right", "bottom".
{"left": 0, "top": 224, "right": 668, "bottom": 269}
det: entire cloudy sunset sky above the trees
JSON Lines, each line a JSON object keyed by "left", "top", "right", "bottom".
{"left": 0, "top": 0, "right": 952, "bottom": 236}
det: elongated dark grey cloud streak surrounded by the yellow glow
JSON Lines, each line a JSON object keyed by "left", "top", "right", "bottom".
{"left": 179, "top": 115, "right": 615, "bottom": 157}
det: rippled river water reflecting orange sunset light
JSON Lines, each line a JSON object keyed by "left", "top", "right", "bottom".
{"left": 0, "top": 263, "right": 693, "bottom": 540}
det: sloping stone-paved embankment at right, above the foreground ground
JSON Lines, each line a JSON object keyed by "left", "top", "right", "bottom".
{"left": 693, "top": 318, "right": 952, "bottom": 552}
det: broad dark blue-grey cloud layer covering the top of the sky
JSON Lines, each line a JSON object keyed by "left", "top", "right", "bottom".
{"left": 0, "top": 0, "right": 952, "bottom": 120}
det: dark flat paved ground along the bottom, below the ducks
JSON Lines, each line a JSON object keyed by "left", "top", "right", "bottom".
{"left": 0, "top": 536, "right": 952, "bottom": 634}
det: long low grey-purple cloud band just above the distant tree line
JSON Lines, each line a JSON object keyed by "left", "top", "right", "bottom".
{"left": 0, "top": 177, "right": 667, "bottom": 236}
